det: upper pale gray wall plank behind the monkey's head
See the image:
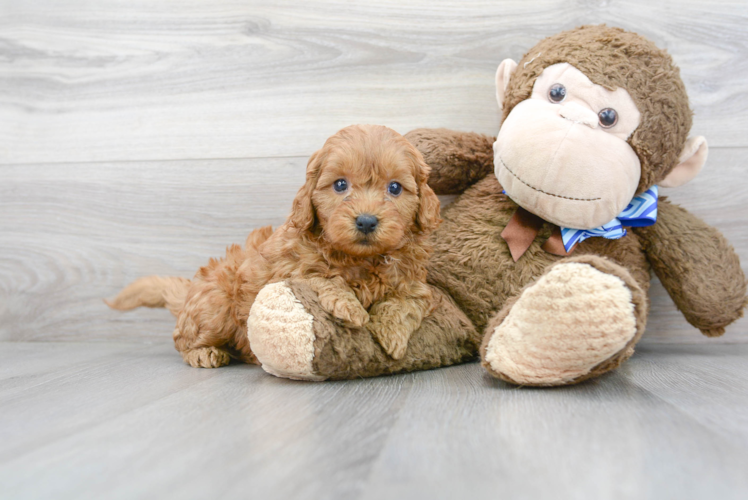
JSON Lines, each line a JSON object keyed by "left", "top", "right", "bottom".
{"left": 0, "top": 0, "right": 748, "bottom": 164}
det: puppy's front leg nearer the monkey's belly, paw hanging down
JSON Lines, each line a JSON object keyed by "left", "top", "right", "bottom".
{"left": 367, "top": 283, "right": 433, "bottom": 359}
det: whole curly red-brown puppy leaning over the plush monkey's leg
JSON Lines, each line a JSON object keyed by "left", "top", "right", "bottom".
{"left": 107, "top": 125, "right": 440, "bottom": 368}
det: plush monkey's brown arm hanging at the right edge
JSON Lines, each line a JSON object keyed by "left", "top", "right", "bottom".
{"left": 634, "top": 198, "right": 748, "bottom": 337}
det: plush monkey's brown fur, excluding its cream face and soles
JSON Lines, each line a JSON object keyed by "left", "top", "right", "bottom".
{"left": 254, "top": 26, "right": 746, "bottom": 385}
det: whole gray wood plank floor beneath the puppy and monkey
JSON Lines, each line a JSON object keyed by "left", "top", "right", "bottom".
{"left": 0, "top": 339, "right": 748, "bottom": 500}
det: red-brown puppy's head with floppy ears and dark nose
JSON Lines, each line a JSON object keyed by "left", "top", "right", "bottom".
{"left": 292, "top": 125, "right": 439, "bottom": 257}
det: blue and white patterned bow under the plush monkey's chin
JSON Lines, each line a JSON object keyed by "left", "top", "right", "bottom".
{"left": 561, "top": 186, "right": 659, "bottom": 252}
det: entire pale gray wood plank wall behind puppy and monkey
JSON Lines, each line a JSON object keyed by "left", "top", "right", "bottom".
{"left": 0, "top": 0, "right": 748, "bottom": 342}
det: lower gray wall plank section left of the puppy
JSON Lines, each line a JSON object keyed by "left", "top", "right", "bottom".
{"left": 0, "top": 158, "right": 306, "bottom": 340}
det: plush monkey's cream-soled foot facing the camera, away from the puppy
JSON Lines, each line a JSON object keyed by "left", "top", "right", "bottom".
{"left": 481, "top": 256, "right": 647, "bottom": 386}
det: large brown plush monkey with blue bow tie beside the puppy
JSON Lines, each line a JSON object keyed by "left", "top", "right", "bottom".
{"left": 248, "top": 26, "right": 746, "bottom": 386}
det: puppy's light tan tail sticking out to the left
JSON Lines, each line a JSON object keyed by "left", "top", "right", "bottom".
{"left": 104, "top": 276, "right": 191, "bottom": 316}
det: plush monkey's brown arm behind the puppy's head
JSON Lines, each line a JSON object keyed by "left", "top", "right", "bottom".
{"left": 405, "top": 128, "right": 495, "bottom": 194}
